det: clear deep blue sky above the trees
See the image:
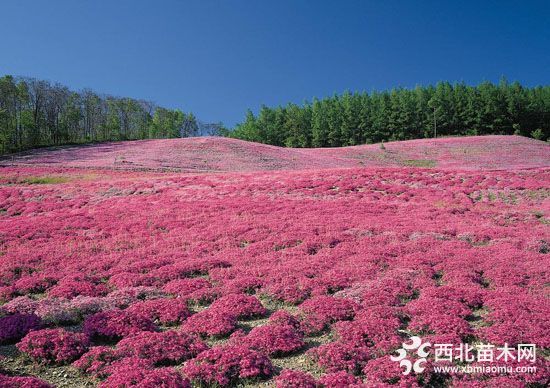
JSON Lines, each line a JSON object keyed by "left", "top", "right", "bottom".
{"left": 0, "top": 0, "right": 550, "bottom": 126}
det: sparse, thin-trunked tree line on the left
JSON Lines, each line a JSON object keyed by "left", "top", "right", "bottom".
{"left": 0, "top": 75, "right": 200, "bottom": 154}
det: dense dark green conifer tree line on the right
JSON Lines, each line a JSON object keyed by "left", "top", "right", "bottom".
{"left": 228, "top": 79, "right": 550, "bottom": 147}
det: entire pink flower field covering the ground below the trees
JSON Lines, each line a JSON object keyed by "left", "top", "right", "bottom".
{"left": 0, "top": 136, "right": 550, "bottom": 387}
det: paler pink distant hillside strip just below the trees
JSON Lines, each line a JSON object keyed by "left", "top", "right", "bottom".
{"left": 0, "top": 136, "right": 550, "bottom": 172}
